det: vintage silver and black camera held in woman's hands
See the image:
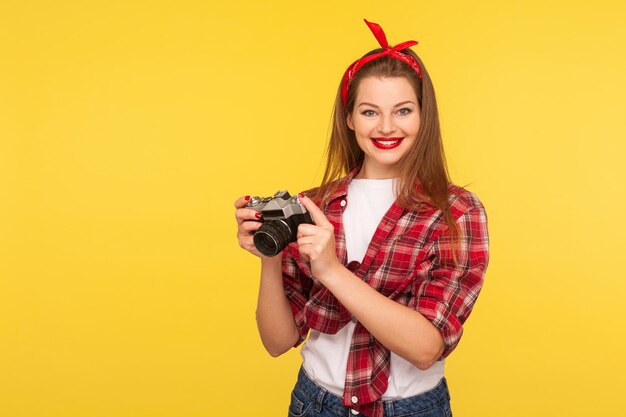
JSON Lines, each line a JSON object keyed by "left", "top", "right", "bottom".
{"left": 246, "top": 191, "right": 315, "bottom": 256}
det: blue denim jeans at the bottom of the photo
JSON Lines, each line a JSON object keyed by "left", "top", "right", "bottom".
{"left": 289, "top": 368, "right": 452, "bottom": 417}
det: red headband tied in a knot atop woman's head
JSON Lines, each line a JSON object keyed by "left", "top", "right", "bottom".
{"left": 341, "top": 19, "right": 422, "bottom": 107}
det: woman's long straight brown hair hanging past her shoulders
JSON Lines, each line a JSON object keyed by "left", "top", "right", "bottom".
{"left": 312, "top": 48, "right": 458, "bottom": 240}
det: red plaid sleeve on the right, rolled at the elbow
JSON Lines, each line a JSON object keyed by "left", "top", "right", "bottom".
{"left": 415, "top": 206, "right": 489, "bottom": 357}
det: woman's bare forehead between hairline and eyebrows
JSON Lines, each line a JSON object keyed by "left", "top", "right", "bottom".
{"left": 355, "top": 77, "right": 417, "bottom": 106}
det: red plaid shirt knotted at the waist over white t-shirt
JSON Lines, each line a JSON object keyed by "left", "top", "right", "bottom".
{"left": 283, "top": 169, "right": 489, "bottom": 417}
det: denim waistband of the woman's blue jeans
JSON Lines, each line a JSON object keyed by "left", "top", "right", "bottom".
{"left": 295, "top": 368, "right": 450, "bottom": 417}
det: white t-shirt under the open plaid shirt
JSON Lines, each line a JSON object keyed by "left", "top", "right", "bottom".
{"left": 301, "top": 179, "right": 444, "bottom": 400}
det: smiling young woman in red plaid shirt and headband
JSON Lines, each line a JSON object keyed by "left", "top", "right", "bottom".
{"left": 235, "top": 21, "right": 488, "bottom": 417}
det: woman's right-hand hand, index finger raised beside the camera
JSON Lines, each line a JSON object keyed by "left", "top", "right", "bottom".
{"left": 298, "top": 194, "right": 342, "bottom": 284}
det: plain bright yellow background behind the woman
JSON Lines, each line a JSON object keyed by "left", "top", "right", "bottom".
{"left": 0, "top": 0, "right": 626, "bottom": 417}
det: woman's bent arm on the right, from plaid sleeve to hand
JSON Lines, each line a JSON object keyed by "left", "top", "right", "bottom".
{"left": 298, "top": 194, "right": 486, "bottom": 369}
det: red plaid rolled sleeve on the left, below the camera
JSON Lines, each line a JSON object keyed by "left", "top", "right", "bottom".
{"left": 282, "top": 245, "right": 313, "bottom": 347}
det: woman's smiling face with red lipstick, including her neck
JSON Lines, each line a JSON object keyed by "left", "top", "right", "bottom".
{"left": 347, "top": 77, "right": 420, "bottom": 179}
